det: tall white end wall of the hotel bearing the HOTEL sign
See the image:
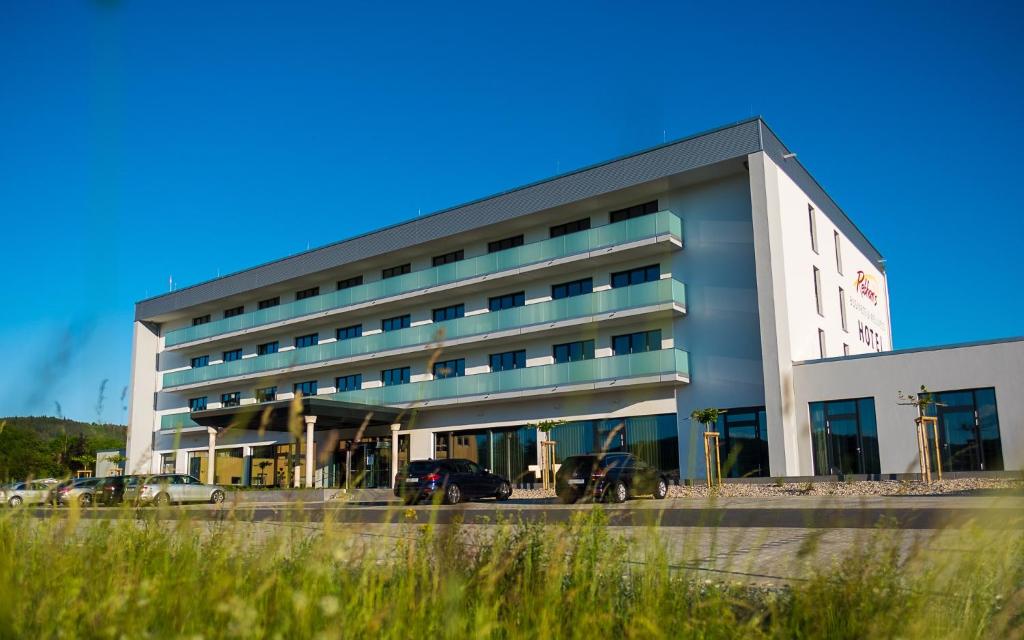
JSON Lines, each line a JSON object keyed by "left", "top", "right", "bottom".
{"left": 748, "top": 153, "right": 892, "bottom": 476}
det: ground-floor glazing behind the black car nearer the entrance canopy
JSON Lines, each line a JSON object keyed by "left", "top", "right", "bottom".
{"left": 434, "top": 426, "right": 537, "bottom": 488}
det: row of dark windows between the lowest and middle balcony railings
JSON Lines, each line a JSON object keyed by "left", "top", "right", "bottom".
{"left": 188, "top": 329, "right": 662, "bottom": 412}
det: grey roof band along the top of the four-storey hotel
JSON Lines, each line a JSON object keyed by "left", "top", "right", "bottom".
{"left": 135, "top": 118, "right": 882, "bottom": 319}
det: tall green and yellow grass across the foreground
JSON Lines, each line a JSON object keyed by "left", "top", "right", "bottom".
{"left": 0, "top": 508, "right": 1024, "bottom": 640}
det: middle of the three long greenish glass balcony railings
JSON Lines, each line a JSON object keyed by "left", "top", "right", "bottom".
{"left": 164, "top": 280, "right": 686, "bottom": 389}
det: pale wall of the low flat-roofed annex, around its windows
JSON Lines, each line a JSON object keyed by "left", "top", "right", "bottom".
{"left": 793, "top": 339, "right": 1024, "bottom": 473}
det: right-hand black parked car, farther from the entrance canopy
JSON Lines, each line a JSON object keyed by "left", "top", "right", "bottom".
{"left": 555, "top": 454, "right": 669, "bottom": 503}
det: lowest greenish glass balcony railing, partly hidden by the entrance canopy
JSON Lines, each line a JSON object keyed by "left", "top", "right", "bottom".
{"left": 160, "top": 349, "right": 689, "bottom": 429}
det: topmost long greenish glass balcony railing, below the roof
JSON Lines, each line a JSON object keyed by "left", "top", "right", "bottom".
{"left": 164, "top": 211, "right": 683, "bottom": 347}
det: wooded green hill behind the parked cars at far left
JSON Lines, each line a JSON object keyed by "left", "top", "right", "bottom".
{"left": 0, "top": 416, "right": 128, "bottom": 481}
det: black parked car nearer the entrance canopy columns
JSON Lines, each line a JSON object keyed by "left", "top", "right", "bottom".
{"left": 394, "top": 458, "right": 512, "bottom": 505}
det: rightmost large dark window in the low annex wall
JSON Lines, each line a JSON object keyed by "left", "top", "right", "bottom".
{"left": 928, "top": 387, "right": 1002, "bottom": 471}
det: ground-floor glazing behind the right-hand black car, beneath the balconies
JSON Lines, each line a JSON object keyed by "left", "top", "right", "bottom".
{"left": 550, "top": 414, "right": 679, "bottom": 475}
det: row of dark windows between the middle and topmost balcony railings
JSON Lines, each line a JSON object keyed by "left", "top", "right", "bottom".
{"left": 190, "top": 264, "right": 662, "bottom": 369}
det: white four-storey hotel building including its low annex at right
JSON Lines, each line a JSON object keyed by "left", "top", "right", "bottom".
{"left": 127, "top": 119, "right": 1024, "bottom": 486}
